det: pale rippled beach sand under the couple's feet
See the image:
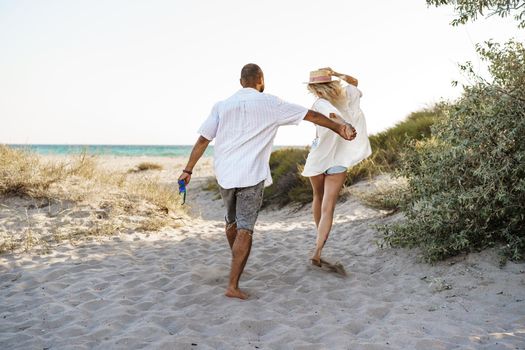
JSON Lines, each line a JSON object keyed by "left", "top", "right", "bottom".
{"left": 0, "top": 156, "right": 525, "bottom": 350}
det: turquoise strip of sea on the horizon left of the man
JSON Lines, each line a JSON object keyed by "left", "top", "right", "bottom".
{"left": 9, "top": 145, "right": 213, "bottom": 157}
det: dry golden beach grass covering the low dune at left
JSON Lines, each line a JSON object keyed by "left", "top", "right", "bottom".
{"left": 0, "top": 146, "right": 184, "bottom": 251}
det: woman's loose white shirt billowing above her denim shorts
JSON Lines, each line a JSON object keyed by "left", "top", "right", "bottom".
{"left": 302, "top": 85, "right": 372, "bottom": 176}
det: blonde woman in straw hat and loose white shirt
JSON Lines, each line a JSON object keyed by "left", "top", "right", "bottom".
{"left": 302, "top": 68, "right": 372, "bottom": 266}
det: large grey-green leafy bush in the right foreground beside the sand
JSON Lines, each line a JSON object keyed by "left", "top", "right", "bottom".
{"left": 383, "top": 42, "right": 525, "bottom": 261}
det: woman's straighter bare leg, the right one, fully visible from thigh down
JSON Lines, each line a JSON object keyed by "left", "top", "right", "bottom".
{"left": 312, "top": 172, "right": 346, "bottom": 265}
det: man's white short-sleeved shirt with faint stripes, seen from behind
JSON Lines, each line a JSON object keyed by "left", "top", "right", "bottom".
{"left": 199, "top": 88, "right": 308, "bottom": 189}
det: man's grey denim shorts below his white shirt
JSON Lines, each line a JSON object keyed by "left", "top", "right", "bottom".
{"left": 219, "top": 180, "right": 264, "bottom": 232}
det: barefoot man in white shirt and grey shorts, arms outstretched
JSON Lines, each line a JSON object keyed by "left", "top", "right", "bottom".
{"left": 179, "top": 64, "right": 356, "bottom": 299}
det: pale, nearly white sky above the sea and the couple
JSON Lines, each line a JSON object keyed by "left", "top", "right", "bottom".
{"left": 0, "top": 0, "right": 525, "bottom": 145}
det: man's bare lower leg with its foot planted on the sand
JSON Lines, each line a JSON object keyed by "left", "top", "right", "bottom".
{"left": 225, "top": 229, "right": 252, "bottom": 299}
